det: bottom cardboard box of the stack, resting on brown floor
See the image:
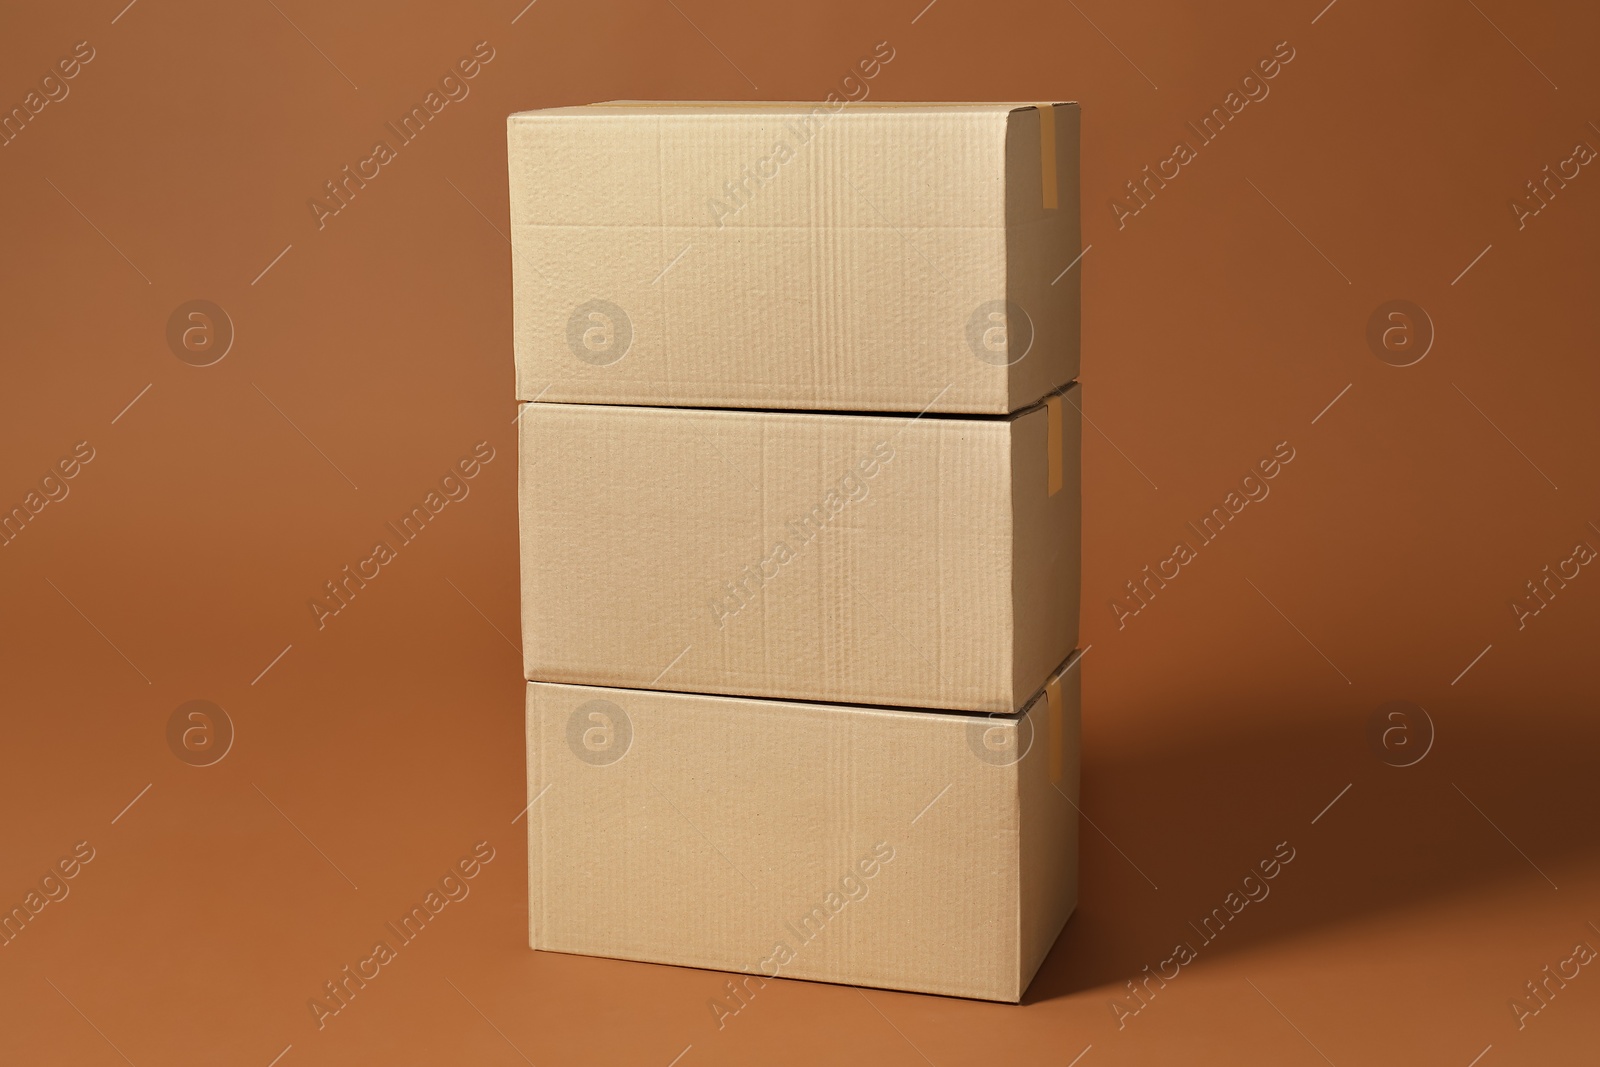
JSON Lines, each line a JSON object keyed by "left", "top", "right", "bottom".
{"left": 526, "top": 662, "right": 1080, "bottom": 1004}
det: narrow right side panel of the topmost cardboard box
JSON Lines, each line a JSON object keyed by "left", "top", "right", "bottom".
{"left": 1006, "top": 104, "right": 1083, "bottom": 411}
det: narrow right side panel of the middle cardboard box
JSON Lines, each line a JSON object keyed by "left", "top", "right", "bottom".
{"left": 1010, "top": 386, "right": 1083, "bottom": 702}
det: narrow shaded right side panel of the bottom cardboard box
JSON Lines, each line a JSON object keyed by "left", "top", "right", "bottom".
{"left": 1018, "top": 659, "right": 1082, "bottom": 998}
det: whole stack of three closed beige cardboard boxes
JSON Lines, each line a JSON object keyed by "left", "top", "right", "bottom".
{"left": 509, "top": 102, "right": 1080, "bottom": 1011}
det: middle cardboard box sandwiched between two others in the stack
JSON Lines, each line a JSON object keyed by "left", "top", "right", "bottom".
{"left": 520, "top": 386, "right": 1082, "bottom": 712}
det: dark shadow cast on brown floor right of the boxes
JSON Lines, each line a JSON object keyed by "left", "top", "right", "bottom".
{"left": 1024, "top": 687, "right": 1600, "bottom": 1003}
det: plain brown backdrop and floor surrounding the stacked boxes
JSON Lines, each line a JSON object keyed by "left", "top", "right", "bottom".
{"left": 0, "top": 0, "right": 1600, "bottom": 1067}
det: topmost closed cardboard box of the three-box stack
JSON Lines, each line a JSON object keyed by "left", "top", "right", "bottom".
{"left": 507, "top": 102, "right": 1080, "bottom": 414}
